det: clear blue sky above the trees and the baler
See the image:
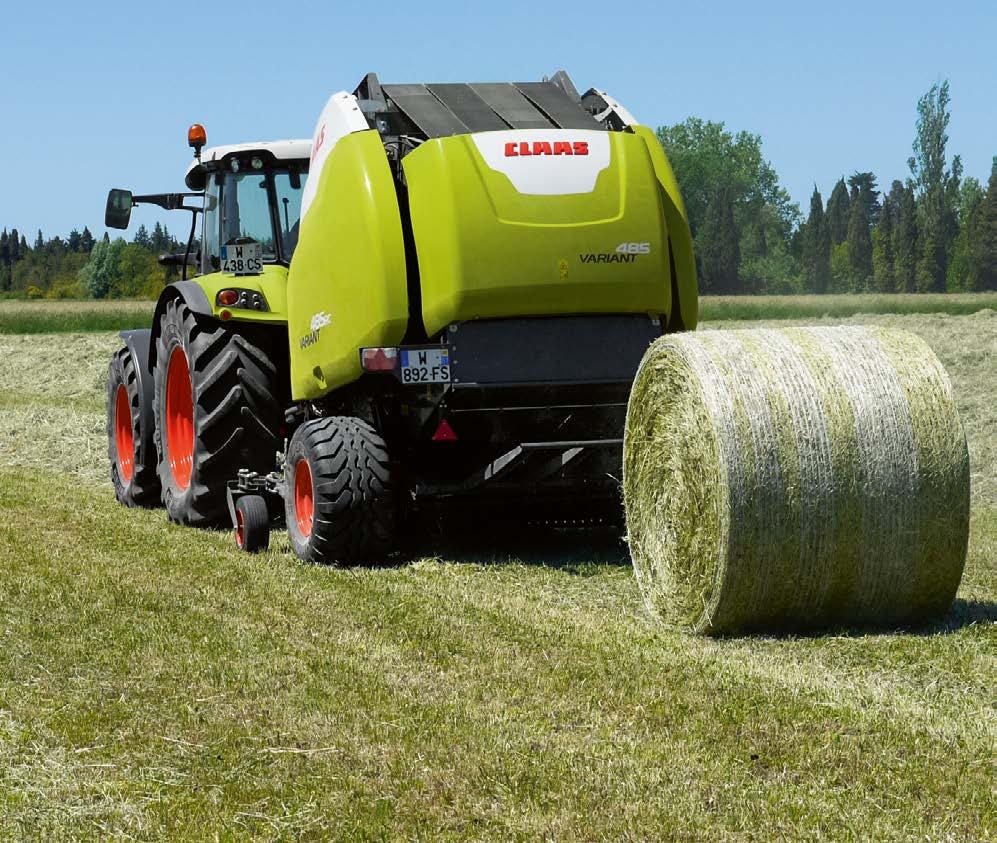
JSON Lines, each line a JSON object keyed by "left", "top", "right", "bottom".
{"left": 0, "top": 0, "right": 997, "bottom": 240}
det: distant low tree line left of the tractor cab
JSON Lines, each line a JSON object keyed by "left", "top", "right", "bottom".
{"left": 0, "top": 222, "right": 183, "bottom": 299}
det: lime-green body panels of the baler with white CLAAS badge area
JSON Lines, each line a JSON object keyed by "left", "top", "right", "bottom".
{"left": 287, "top": 120, "right": 697, "bottom": 400}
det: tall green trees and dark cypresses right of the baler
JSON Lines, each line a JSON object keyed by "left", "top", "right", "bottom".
{"left": 658, "top": 82, "right": 997, "bottom": 294}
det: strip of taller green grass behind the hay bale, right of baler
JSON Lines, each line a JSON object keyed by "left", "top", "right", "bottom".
{"left": 699, "top": 293, "right": 997, "bottom": 321}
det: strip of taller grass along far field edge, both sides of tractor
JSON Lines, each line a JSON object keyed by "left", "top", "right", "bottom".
{"left": 0, "top": 293, "right": 997, "bottom": 334}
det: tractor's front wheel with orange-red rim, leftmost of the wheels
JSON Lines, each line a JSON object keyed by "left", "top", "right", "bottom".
{"left": 107, "top": 348, "right": 160, "bottom": 507}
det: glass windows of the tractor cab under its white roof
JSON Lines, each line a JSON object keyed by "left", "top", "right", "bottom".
{"left": 202, "top": 158, "right": 308, "bottom": 272}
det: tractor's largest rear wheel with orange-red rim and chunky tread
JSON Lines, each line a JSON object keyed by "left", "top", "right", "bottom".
{"left": 153, "top": 299, "right": 282, "bottom": 527}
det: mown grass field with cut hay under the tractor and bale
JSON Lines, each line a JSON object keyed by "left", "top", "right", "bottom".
{"left": 0, "top": 302, "right": 997, "bottom": 841}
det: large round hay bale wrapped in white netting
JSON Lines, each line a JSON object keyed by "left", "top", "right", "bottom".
{"left": 623, "top": 327, "right": 969, "bottom": 634}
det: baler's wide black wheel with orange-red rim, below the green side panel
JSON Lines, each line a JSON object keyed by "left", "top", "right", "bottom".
{"left": 284, "top": 416, "right": 397, "bottom": 565}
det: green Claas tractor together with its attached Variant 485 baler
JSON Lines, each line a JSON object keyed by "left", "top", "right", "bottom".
{"left": 106, "top": 72, "right": 697, "bottom": 563}
